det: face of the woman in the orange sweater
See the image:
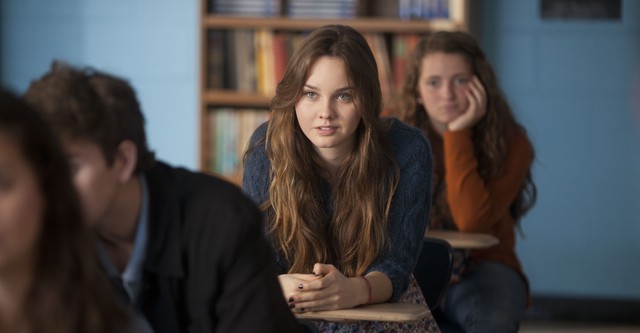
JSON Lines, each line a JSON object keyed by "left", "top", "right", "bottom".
{"left": 418, "top": 52, "right": 473, "bottom": 133}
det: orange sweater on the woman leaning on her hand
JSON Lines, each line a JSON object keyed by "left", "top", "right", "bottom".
{"left": 443, "top": 130, "right": 533, "bottom": 284}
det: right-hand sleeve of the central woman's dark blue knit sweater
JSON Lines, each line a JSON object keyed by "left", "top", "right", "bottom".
{"left": 368, "top": 120, "right": 433, "bottom": 302}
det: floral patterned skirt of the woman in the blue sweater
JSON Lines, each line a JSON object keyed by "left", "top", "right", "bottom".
{"left": 314, "top": 276, "right": 440, "bottom": 333}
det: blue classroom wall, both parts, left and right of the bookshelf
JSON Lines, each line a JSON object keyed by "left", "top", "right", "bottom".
{"left": 0, "top": 0, "right": 640, "bottom": 299}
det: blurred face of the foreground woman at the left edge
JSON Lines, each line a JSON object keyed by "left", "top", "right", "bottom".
{"left": 0, "top": 132, "right": 44, "bottom": 274}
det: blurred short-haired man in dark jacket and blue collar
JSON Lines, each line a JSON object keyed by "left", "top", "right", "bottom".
{"left": 20, "top": 63, "right": 300, "bottom": 333}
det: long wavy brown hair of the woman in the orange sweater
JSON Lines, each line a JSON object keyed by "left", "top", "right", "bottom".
{"left": 398, "top": 31, "right": 537, "bottom": 222}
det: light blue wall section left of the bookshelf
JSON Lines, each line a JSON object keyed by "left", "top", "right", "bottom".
{"left": 0, "top": 0, "right": 199, "bottom": 168}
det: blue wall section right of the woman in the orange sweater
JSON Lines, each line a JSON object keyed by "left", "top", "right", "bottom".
{"left": 479, "top": 0, "right": 640, "bottom": 299}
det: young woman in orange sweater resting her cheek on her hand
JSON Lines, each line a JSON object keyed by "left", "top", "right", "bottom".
{"left": 399, "top": 32, "right": 536, "bottom": 332}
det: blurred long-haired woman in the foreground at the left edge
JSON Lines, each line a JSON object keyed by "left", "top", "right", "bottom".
{"left": 0, "top": 91, "right": 141, "bottom": 333}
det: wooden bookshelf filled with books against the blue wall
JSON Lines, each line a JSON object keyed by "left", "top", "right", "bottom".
{"left": 198, "top": 0, "right": 469, "bottom": 184}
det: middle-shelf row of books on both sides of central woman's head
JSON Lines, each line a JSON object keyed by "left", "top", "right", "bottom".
{"left": 206, "top": 29, "right": 420, "bottom": 107}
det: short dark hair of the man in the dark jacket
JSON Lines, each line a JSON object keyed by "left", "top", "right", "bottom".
{"left": 24, "top": 61, "right": 155, "bottom": 174}
